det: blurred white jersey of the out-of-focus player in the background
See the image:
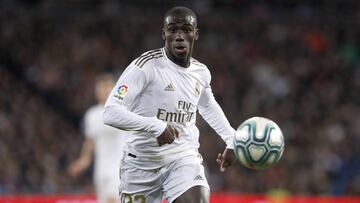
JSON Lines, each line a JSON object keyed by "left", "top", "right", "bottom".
{"left": 84, "top": 104, "right": 126, "bottom": 180}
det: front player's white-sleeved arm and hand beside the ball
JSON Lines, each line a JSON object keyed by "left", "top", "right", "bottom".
{"left": 198, "top": 85, "right": 236, "bottom": 171}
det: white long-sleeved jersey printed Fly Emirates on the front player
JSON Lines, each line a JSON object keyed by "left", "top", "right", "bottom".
{"left": 104, "top": 48, "right": 235, "bottom": 169}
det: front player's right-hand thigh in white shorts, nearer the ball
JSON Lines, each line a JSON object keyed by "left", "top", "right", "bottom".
{"left": 163, "top": 157, "right": 209, "bottom": 203}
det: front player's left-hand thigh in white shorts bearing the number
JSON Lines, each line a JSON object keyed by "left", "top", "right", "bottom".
{"left": 120, "top": 162, "right": 162, "bottom": 203}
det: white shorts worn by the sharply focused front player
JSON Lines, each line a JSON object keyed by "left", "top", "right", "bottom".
{"left": 120, "top": 155, "right": 210, "bottom": 203}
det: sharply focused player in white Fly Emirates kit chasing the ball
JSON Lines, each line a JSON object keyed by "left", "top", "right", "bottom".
{"left": 104, "top": 7, "right": 235, "bottom": 203}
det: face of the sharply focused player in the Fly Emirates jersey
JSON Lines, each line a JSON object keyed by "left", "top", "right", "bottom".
{"left": 163, "top": 14, "right": 198, "bottom": 64}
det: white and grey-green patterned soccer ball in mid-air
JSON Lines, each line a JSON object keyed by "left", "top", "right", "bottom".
{"left": 234, "top": 117, "right": 285, "bottom": 169}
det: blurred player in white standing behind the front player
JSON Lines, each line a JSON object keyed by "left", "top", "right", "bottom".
{"left": 68, "top": 74, "right": 125, "bottom": 203}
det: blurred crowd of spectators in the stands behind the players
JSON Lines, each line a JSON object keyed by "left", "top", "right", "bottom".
{"left": 0, "top": 0, "right": 360, "bottom": 195}
